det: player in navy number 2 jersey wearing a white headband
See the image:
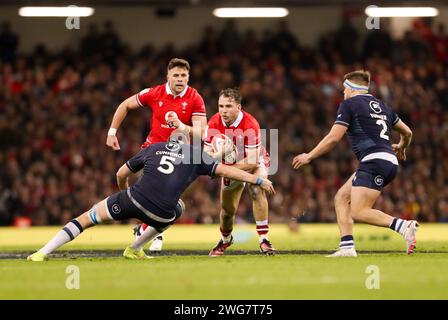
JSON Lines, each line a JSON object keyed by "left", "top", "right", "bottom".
{"left": 292, "top": 70, "right": 418, "bottom": 257}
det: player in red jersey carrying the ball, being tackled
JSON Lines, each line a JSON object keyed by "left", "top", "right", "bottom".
{"left": 204, "top": 89, "right": 275, "bottom": 257}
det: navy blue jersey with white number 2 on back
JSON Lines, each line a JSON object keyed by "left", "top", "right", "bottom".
{"left": 335, "top": 94, "right": 400, "bottom": 160}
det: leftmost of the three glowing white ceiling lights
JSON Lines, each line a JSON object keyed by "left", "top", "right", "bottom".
{"left": 19, "top": 6, "right": 95, "bottom": 17}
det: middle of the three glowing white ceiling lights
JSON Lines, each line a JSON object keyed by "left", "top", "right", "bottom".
{"left": 213, "top": 8, "right": 289, "bottom": 18}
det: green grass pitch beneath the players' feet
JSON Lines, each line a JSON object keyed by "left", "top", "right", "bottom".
{"left": 0, "top": 224, "right": 448, "bottom": 300}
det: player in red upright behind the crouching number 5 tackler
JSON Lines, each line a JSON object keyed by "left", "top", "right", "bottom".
{"left": 106, "top": 58, "right": 207, "bottom": 251}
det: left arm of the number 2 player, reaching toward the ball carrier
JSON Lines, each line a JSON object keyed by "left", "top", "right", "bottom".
{"left": 292, "top": 124, "right": 347, "bottom": 169}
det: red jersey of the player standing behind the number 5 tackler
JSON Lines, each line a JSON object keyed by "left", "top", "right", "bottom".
{"left": 136, "top": 82, "right": 206, "bottom": 147}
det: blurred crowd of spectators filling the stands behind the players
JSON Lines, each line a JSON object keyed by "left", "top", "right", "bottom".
{"left": 0, "top": 21, "right": 448, "bottom": 225}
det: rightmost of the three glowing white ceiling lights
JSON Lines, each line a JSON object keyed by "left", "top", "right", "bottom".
{"left": 365, "top": 6, "right": 439, "bottom": 18}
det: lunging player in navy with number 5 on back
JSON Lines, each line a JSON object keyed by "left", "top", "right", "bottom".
{"left": 27, "top": 142, "right": 275, "bottom": 261}
